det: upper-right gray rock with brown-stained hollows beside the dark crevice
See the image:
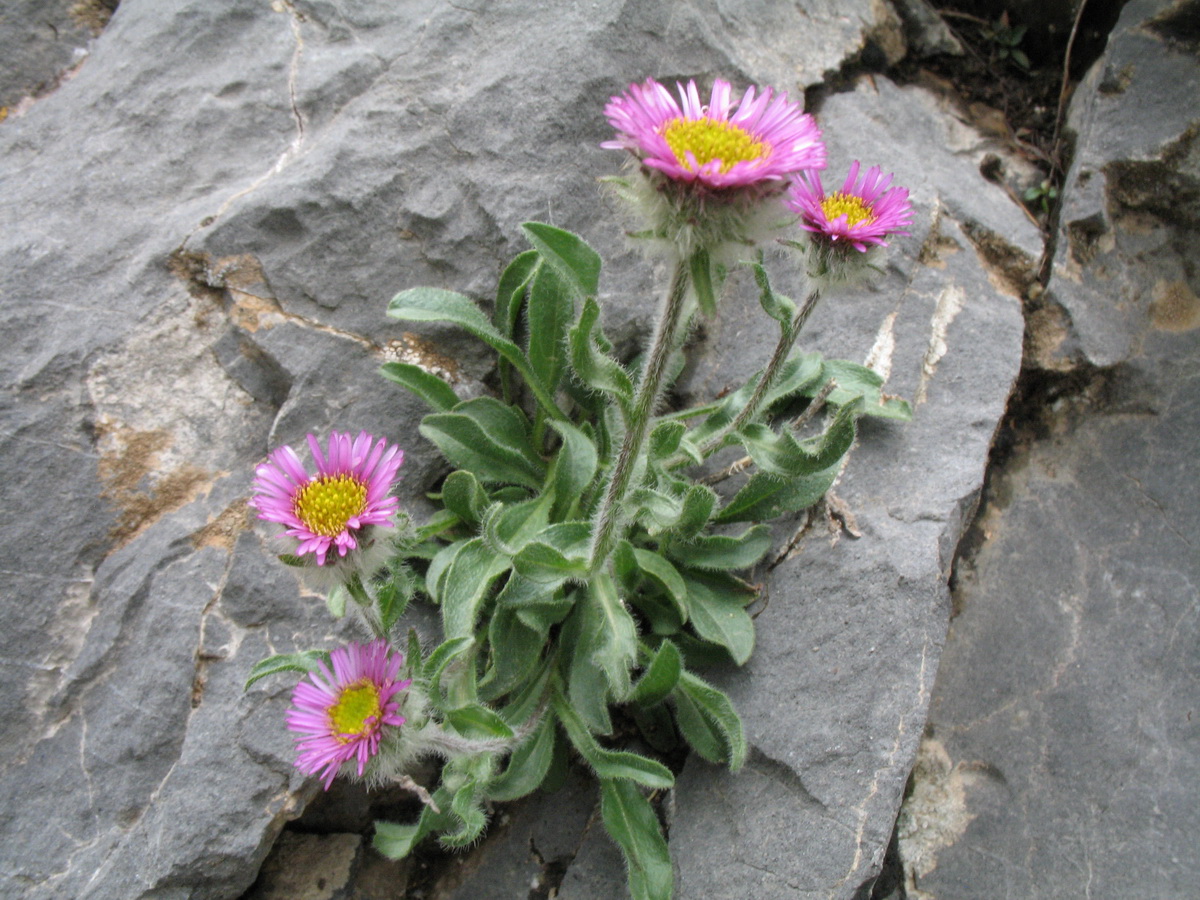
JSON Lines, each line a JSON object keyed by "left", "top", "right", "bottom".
{"left": 1048, "top": 0, "right": 1200, "bottom": 366}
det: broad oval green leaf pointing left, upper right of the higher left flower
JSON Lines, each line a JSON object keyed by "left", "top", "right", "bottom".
{"left": 420, "top": 397, "right": 545, "bottom": 490}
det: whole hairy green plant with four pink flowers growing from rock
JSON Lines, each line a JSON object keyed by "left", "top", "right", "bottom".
{"left": 250, "top": 80, "right": 911, "bottom": 899}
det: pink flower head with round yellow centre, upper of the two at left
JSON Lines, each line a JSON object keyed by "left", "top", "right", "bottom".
{"left": 250, "top": 431, "right": 404, "bottom": 565}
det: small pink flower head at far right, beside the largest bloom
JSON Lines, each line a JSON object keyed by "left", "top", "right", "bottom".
{"left": 787, "top": 160, "right": 912, "bottom": 251}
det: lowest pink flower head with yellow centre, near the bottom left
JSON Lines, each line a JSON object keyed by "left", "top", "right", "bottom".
{"left": 287, "top": 638, "right": 412, "bottom": 791}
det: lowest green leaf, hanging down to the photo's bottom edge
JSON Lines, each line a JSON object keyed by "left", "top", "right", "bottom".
{"left": 600, "top": 779, "right": 674, "bottom": 900}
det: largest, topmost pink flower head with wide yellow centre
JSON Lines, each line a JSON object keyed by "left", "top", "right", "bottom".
{"left": 600, "top": 78, "right": 826, "bottom": 190}
